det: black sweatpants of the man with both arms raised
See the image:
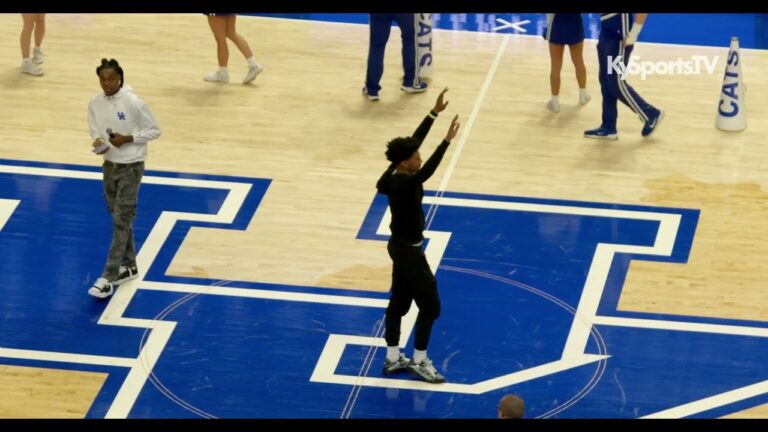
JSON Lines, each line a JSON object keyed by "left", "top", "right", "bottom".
{"left": 385, "top": 240, "right": 440, "bottom": 351}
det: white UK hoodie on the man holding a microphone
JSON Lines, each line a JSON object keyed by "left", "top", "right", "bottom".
{"left": 88, "top": 86, "right": 160, "bottom": 163}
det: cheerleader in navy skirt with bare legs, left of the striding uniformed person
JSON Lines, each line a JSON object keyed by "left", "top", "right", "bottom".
{"left": 544, "top": 13, "right": 592, "bottom": 113}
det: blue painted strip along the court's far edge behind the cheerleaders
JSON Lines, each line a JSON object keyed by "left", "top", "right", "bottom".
{"left": 245, "top": 13, "right": 768, "bottom": 49}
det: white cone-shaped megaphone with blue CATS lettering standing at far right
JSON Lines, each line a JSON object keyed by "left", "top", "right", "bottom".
{"left": 715, "top": 36, "right": 747, "bottom": 131}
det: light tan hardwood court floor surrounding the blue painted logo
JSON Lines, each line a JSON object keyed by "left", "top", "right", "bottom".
{"left": 0, "top": 14, "right": 768, "bottom": 417}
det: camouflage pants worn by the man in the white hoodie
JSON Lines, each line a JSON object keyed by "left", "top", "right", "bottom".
{"left": 101, "top": 161, "right": 144, "bottom": 281}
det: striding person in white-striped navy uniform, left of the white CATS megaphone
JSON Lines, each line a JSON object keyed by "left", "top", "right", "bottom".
{"left": 584, "top": 13, "right": 664, "bottom": 139}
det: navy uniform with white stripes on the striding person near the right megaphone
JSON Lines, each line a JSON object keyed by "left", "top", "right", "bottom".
{"left": 597, "top": 13, "right": 659, "bottom": 131}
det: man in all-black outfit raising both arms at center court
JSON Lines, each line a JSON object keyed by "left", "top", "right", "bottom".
{"left": 376, "top": 88, "right": 460, "bottom": 383}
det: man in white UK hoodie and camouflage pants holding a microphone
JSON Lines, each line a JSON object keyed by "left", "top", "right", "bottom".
{"left": 88, "top": 59, "right": 160, "bottom": 298}
